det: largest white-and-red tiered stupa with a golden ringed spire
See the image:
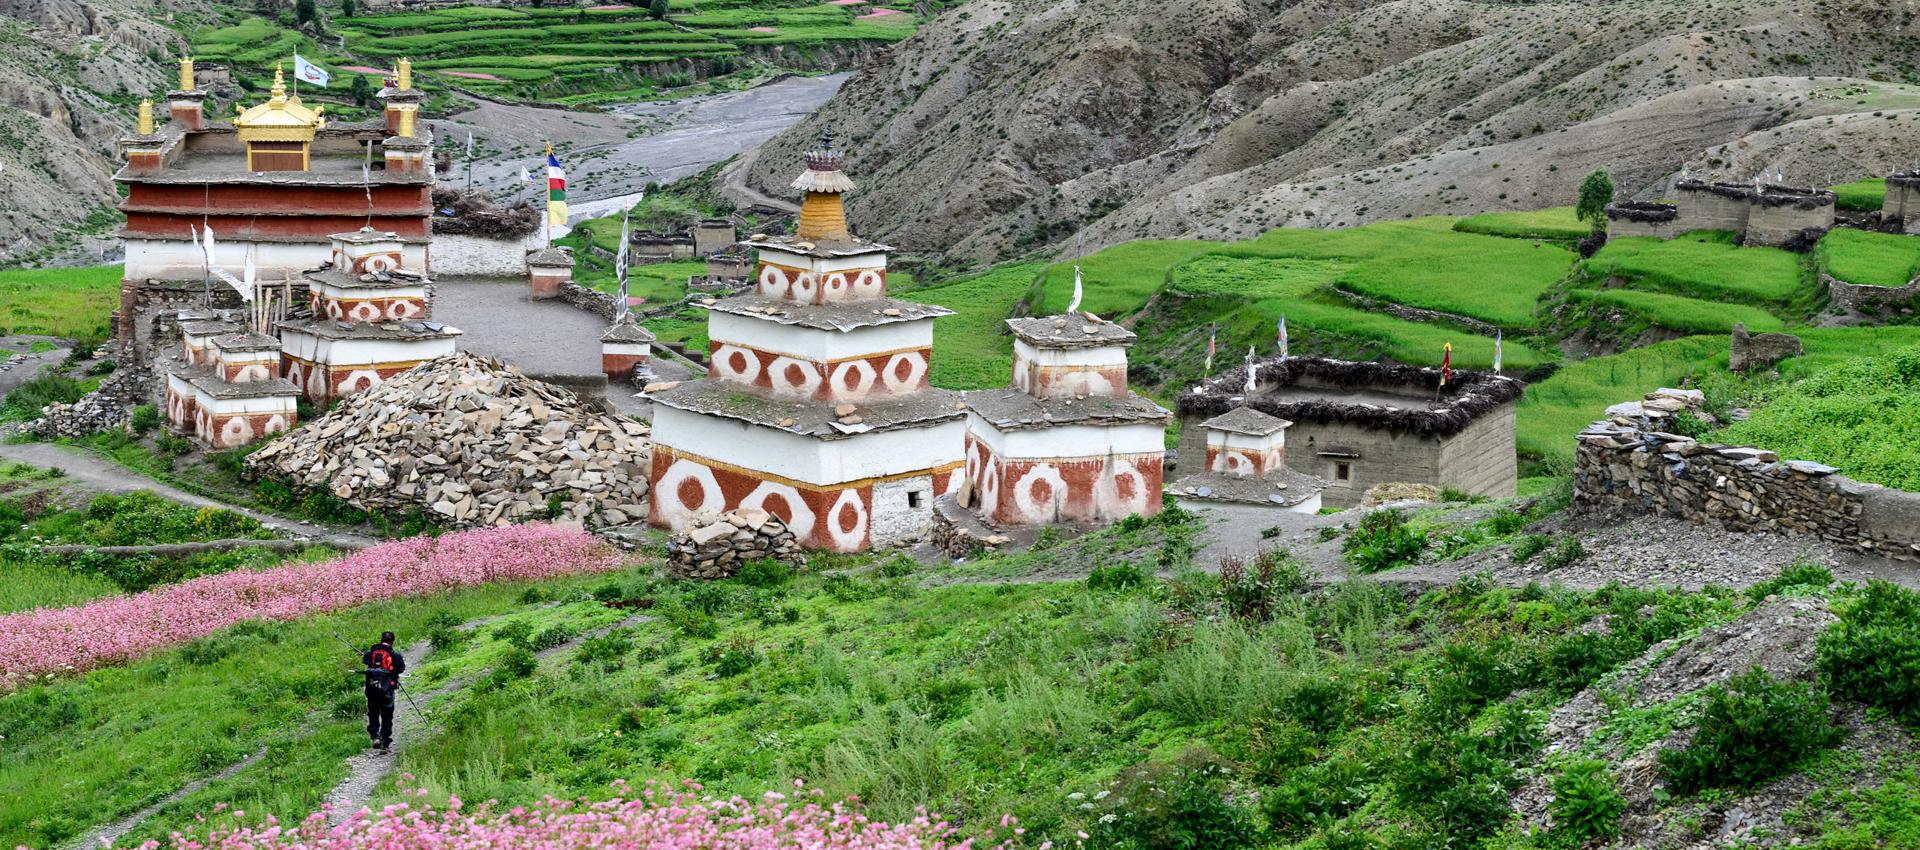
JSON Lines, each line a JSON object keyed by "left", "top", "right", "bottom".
{"left": 649, "top": 142, "right": 966, "bottom": 553}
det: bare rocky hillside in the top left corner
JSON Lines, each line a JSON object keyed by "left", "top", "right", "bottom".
{"left": 0, "top": 0, "right": 186, "bottom": 261}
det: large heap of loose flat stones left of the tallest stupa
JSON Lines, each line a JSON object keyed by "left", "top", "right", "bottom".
{"left": 246, "top": 353, "right": 653, "bottom": 528}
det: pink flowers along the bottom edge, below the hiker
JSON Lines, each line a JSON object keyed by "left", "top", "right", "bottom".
{"left": 142, "top": 783, "right": 1046, "bottom": 850}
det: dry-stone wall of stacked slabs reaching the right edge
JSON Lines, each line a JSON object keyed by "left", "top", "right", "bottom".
{"left": 1572, "top": 390, "right": 1920, "bottom": 560}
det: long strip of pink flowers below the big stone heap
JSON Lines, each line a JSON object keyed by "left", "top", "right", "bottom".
{"left": 0, "top": 526, "right": 620, "bottom": 691}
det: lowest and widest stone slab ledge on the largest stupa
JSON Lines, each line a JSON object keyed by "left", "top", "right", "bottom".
{"left": 647, "top": 380, "right": 966, "bottom": 439}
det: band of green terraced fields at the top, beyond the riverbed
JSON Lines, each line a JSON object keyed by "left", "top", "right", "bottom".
{"left": 192, "top": 0, "right": 918, "bottom": 102}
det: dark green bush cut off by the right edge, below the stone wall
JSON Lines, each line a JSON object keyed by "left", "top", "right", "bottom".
{"left": 1818, "top": 579, "right": 1920, "bottom": 727}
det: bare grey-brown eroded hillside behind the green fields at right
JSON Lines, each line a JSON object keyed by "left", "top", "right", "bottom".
{"left": 747, "top": 0, "right": 1920, "bottom": 259}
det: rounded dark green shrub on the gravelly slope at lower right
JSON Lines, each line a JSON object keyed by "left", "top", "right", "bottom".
{"left": 1661, "top": 668, "right": 1845, "bottom": 794}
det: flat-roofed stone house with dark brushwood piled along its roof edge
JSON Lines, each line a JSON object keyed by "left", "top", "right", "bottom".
{"left": 1177, "top": 357, "right": 1521, "bottom": 507}
